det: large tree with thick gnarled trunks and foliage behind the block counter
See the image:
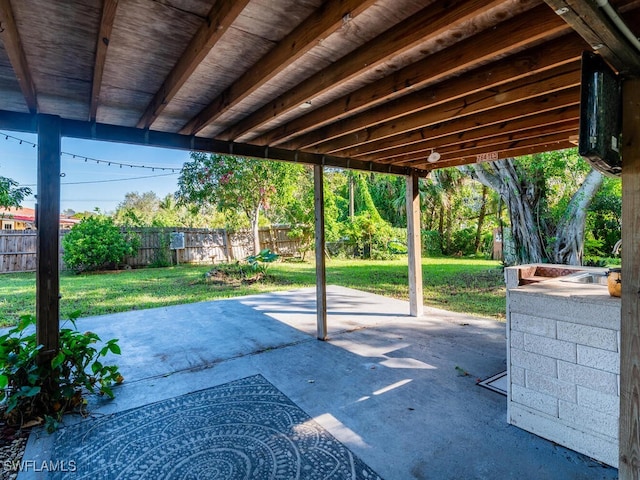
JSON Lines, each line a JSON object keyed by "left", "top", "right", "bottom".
{"left": 460, "top": 150, "right": 602, "bottom": 264}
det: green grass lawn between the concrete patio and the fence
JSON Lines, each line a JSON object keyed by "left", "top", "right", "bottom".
{"left": 0, "top": 258, "right": 505, "bottom": 325}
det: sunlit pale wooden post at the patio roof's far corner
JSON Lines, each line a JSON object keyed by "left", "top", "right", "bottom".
{"left": 407, "top": 171, "right": 424, "bottom": 317}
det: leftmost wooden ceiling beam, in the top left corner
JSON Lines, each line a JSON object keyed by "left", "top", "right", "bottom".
{"left": 0, "top": 0, "right": 38, "bottom": 113}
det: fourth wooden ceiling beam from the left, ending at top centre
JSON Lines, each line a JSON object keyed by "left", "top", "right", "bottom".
{"left": 180, "top": 0, "right": 375, "bottom": 135}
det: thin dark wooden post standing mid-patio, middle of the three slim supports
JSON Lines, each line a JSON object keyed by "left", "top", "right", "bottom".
{"left": 313, "top": 165, "right": 327, "bottom": 340}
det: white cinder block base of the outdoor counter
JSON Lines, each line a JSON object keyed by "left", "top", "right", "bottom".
{"left": 507, "top": 264, "right": 620, "bottom": 467}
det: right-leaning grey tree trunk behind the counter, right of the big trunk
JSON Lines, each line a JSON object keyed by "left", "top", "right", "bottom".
{"left": 553, "top": 169, "right": 604, "bottom": 265}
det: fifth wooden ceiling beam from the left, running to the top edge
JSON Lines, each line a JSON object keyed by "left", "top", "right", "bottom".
{"left": 220, "top": 0, "right": 510, "bottom": 145}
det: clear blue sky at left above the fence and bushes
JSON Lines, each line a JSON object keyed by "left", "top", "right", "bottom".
{"left": 0, "top": 130, "right": 189, "bottom": 213}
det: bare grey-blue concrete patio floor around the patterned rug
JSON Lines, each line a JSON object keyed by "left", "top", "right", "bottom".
{"left": 18, "top": 286, "right": 617, "bottom": 480}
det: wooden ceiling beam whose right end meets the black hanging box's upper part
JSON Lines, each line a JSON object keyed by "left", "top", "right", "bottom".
{"left": 315, "top": 62, "right": 580, "bottom": 154}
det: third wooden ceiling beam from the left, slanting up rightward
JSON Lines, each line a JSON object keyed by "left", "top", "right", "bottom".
{"left": 137, "top": 0, "right": 250, "bottom": 128}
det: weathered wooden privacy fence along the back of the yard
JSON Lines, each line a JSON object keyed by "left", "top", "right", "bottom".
{"left": 0, "top": 227, "right": 299, "bottom": 273}
